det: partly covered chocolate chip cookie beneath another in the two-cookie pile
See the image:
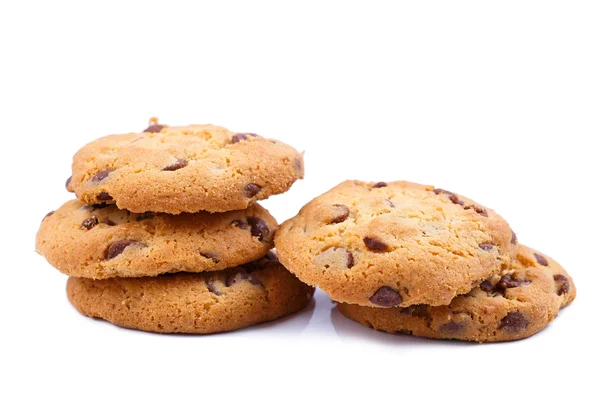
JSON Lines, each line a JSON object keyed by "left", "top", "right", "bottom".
{"left": 337, "top": 245, "right": 576, "bottom": 342}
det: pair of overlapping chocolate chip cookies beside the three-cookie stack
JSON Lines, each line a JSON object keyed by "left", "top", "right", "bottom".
{"left": 275, "top": 181, "right": 575, "bottom": 342}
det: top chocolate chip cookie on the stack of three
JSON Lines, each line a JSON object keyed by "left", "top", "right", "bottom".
{"left": 66, "top": 124, "right": 304, "bottom": 214}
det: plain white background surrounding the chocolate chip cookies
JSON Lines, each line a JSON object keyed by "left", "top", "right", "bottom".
{"left": 0, "top": 1, "right": 600, "bottom": 399}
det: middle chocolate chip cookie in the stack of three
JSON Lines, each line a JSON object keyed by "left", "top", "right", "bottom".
{"left": 36, "top": 200, "right": 277, "bottom": 279}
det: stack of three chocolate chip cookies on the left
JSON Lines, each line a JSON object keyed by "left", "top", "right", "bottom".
{"left": 36, "top": 120, "right": 314, "bottom": 333}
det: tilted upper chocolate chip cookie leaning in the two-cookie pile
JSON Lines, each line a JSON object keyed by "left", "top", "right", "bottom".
{"left": 275, "top": 181, "right": 517, "bottom": 307}
